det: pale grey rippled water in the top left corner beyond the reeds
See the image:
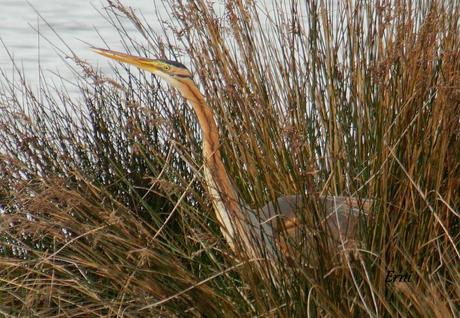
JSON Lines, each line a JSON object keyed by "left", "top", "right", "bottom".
{"left": 0, "top": 0, "right": 161, "bottom": 94}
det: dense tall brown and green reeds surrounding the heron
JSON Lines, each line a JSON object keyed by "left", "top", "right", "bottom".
{"left": 0, "top": 1, "right": 460, "bottom": 317}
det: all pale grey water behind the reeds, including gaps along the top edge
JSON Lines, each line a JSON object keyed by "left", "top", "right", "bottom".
{"left": 0, "top": 0, "right": 294, "bottom": 97}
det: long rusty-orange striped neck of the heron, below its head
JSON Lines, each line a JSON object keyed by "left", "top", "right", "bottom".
{"left": 182, "top": 80, "right": 255, "bottom": 253}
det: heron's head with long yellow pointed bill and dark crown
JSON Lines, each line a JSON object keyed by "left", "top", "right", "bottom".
{"left": 92, "top": 48, "right": 192, "bottom": 88}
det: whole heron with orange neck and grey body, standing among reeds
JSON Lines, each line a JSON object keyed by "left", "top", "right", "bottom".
{"left": 92, "top": 48, "right": 372, "bottom": 261}
